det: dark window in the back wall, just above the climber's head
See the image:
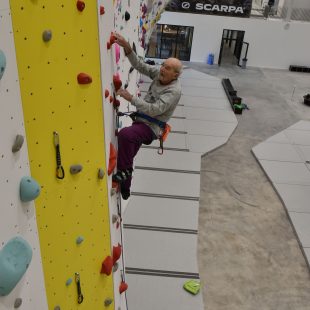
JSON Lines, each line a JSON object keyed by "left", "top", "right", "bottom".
{"left": 146, "top": 24, "right": 194, "bottom": 61}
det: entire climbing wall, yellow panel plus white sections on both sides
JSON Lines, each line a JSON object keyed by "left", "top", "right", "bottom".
{"left": 0, "top": 0, "right": 172, "bottom": 310}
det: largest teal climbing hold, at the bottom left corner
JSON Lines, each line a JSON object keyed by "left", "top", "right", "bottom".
{"left": 0, "top": 237, "right": 32, "bottom": 296}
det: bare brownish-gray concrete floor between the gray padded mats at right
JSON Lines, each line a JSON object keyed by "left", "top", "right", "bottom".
{"left": 186, "top": 63, "right": 310, "bottom": 310}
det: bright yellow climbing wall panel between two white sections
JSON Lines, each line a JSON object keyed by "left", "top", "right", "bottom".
{"left": 11, "top": 0, "right": 113, "bottom": 310}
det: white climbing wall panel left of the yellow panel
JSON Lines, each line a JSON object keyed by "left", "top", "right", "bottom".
{"left": 0, "top": 0, "right": 47, "bottom": 310}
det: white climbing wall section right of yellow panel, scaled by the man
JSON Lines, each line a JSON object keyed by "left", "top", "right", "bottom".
{"left": 98, "top": 0, "right": 173, "bottom": 309}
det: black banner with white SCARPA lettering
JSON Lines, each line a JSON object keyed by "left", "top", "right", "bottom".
{"left": 166, "top": 0, "right": 252, "bottom": 17}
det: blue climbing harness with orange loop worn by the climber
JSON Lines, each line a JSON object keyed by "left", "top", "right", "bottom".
{"left": 117, "top": 112, "right": 171, "bottom": 155}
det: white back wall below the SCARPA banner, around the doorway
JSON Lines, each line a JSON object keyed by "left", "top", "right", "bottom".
{"left": 159, "top": 12, "right": 310, "bottom": 69}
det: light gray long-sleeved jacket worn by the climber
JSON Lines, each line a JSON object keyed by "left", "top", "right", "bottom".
{"left": 127, "top": 52, "right": 181, "bottom": 137}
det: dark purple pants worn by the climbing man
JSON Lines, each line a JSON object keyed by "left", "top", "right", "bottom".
{"left": 117, "top": 122, "right": 157, "bottom": 191}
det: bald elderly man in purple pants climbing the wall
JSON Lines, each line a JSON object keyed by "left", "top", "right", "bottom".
{"left": 113, "top": 33, "right": 182, "bottom": 200}
